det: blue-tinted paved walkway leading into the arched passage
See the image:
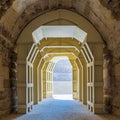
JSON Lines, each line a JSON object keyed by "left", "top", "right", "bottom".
{"left": 16, "top": 98, "right": 104, "bottom": 120}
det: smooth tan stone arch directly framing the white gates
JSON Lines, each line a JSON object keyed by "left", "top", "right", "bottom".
{"left": 17, "top": 10, "right": 103, "bottom": 113}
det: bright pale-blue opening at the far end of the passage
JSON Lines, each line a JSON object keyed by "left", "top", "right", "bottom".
{"left": 53, "top": 57, "right": 73, "bottom": 100}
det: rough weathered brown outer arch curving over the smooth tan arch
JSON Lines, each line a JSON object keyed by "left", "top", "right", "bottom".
{"left": 0, "top": 0, "right": 120, "bottom": 116}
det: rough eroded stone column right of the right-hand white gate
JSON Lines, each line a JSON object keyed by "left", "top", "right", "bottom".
{"left": 103, "top": 48, "right": 114, "bottom": 113}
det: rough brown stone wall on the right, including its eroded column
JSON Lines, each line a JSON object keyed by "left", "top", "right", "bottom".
{"left": 103, "top": 48, "right": 120, "bottom": 115}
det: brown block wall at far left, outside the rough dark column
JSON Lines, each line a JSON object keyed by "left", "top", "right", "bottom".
{"left": 0, "top": 38, "right": 12, "bottom": 116}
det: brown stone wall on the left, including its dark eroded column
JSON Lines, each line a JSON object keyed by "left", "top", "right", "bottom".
{"left": 0, "top": 36, "right": 17, "bottom": 116}
